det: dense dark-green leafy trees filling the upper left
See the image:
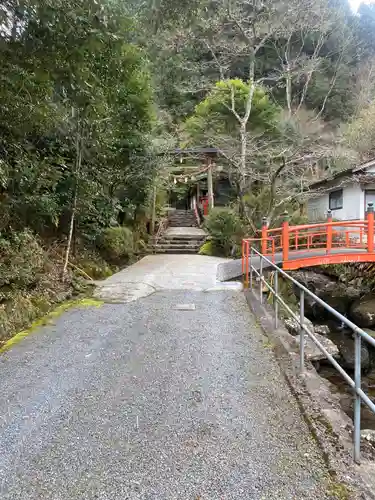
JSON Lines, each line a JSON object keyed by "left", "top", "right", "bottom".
{"left": 0, "top": 0, "right": 155, "bottom": 241}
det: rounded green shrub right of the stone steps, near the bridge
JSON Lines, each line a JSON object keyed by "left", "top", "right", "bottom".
{"left": 205, "top": 208, "right": 243, "bottom": 256}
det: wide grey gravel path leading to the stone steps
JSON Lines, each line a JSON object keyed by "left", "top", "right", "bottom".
{"left": 0, "top": 256, "right": 329, "bottom": 500}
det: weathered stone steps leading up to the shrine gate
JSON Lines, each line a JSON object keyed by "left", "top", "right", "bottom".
{"left": 149, "top": 210, "right": 207, "bottom": 254}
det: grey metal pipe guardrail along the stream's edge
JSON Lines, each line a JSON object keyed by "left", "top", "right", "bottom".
{"left": 245, "top": 247, "right": 375, "bottom": 463}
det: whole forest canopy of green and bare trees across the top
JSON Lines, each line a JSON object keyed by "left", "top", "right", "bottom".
{"left": 0, "top": 0, "right": 375, "bottom": 240}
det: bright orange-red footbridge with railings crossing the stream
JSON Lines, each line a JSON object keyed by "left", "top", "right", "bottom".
{"left": 242, "top": 203, "right": 375, "bottom": 282}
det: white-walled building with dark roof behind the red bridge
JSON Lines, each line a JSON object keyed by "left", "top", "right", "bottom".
{"left": 307, "top": 159, "right": 375, "bottom": 221}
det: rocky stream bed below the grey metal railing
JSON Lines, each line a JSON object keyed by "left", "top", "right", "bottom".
{"left": 283, "top": 265, "right": 375, "bottom": 436}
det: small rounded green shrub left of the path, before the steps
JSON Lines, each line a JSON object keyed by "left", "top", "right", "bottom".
{"left": 99, "top": 226, "right": 134, "bottom": 262}
